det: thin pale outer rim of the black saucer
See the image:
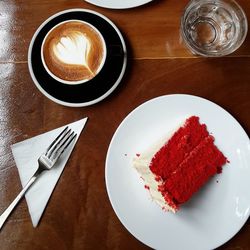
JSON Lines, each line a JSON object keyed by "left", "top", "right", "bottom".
{"left": 28, "top": 8, "right": 127, "bottom": 107}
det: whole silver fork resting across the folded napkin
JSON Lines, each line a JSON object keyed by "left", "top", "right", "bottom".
{"left": 0, "top": 127, "right": 76, "bottom": 230}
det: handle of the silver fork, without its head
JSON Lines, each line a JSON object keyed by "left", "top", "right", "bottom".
{"left": 0, "top": 169, "right": 41, "bottom": 230}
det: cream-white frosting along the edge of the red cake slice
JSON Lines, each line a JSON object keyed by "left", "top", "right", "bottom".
{"left": 133, "top": 119, "right": 186, "bottom": 213}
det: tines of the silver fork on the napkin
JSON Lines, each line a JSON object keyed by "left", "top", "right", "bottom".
{"left": 45, "top": 126, "right": 77, "bottom": 161}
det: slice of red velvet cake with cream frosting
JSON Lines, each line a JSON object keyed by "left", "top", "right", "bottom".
{"left": 134, "top": 116, "right": 227, "bottom": 212}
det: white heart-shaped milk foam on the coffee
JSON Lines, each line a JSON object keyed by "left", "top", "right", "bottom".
{"left": 53, "top": 32, "right": 91, "bottom": 67}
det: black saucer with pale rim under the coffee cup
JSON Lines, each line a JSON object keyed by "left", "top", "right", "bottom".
{"left": 28, "top": 9, "right": 127, "bottom": 107}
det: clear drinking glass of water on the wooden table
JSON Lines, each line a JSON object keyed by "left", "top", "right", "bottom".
{"left": 181, "top": 0, "right": 248, "bottom": 57}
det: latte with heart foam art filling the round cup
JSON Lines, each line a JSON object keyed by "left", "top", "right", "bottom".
{"left": 41, "top": 20, "right": 106, "bottom": 83}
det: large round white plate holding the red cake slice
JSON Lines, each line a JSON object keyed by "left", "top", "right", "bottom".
{"left": 105, "top": 95, "right": 250, "bottom": 250}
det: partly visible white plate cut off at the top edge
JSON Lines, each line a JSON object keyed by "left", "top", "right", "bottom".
{"left": 85, "top": 0, "right": 152, "bottom": 9}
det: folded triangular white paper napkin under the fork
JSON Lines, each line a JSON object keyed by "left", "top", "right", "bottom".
{"left": 11, "top": 118, "right": 88, "bottom": 227}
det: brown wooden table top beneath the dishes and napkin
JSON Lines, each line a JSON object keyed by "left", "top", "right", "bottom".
{"left": 0, "top": 0, "right": 250, "bottom": 250}
